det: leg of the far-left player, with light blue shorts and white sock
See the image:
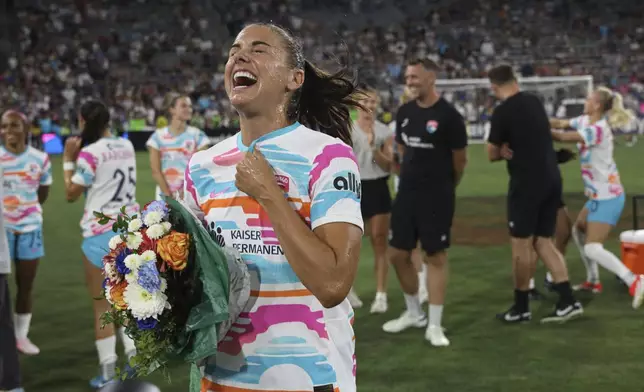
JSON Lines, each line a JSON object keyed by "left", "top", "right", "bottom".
{"left": 14, "top": 229, "right": 45, "bottom": 355}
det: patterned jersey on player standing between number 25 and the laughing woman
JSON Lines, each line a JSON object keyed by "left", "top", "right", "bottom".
{"left": 146, "top": 126, "right": 208, "bottom": 193}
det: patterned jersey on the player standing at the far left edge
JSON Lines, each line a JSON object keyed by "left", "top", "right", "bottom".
{"left": 0, "top": 146, "right": 52, "bottom": 233}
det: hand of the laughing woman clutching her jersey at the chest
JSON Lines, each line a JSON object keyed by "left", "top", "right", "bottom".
{"left": 235, "top": 148, "right": 281, "bottom": 202}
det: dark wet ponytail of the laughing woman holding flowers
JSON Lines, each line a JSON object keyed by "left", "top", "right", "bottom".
{"left": 289, "top": 61, "right": 364, "bottom": 145}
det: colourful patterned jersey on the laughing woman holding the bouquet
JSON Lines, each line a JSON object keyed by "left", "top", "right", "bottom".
{"left": 185, "top": 123, "right": 362, "bottom": 392}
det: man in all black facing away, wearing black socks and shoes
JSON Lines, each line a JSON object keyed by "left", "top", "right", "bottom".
{"left": 488, "top": 65, "right": 583, "bottom": 323}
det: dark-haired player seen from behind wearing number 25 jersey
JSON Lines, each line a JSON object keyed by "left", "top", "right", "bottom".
{"left": 63, "top": 101, "right": 139, "bottom": 389}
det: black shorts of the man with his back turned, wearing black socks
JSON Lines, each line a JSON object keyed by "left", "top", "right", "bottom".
{"left": 508, "top": 182, "right": 563, "bottom": 238}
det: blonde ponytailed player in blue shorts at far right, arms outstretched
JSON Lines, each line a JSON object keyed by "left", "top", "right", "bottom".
{"left": 550, "top": 87, "right": 644, "bottom": 309}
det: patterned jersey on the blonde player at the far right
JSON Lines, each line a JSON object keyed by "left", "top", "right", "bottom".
{"left": 570, "top": 115, "right": 624, "bottom": 200}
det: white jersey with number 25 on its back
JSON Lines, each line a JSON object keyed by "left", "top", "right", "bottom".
{"left": 72, "top": 137, "right": 139, "bottom": 237}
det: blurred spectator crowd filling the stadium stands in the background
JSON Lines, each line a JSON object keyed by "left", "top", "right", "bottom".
{"left": 0, "top": 0, "right": 644, "bottom": 132}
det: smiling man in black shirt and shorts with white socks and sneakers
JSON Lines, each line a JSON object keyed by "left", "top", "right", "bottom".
{"left": 382, "top": 59, "right": 467, "bottom": 346}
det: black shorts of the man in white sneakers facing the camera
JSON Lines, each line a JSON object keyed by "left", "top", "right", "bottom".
{"left": 389, "top": 190, "right": 455, "bottom": 254}
